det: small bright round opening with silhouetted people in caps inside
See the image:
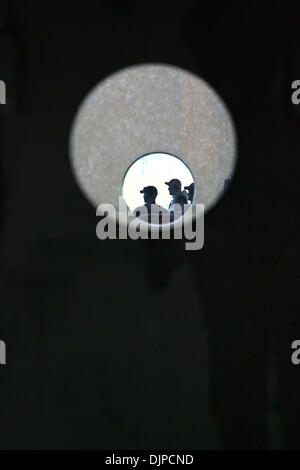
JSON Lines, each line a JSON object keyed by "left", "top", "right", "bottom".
{"left": 122, "top": 152, "right": 195, "bottom": 223}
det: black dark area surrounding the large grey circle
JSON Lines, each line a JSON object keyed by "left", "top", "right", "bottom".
{"left": 0, "top": 0, "right": 300, "bottom": 449}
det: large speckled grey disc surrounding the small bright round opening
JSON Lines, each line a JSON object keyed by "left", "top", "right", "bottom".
{"left": 70, "top": 64, "right": 236, "bottom": 222}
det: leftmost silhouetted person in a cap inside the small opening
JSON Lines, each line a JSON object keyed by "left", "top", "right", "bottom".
{"left": 134, "top": 186, "right": 169, "bottom": 224}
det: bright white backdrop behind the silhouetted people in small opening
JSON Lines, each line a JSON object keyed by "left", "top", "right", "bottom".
{"left": 123, "top": 153, "right": 194, "bottom": 211}
